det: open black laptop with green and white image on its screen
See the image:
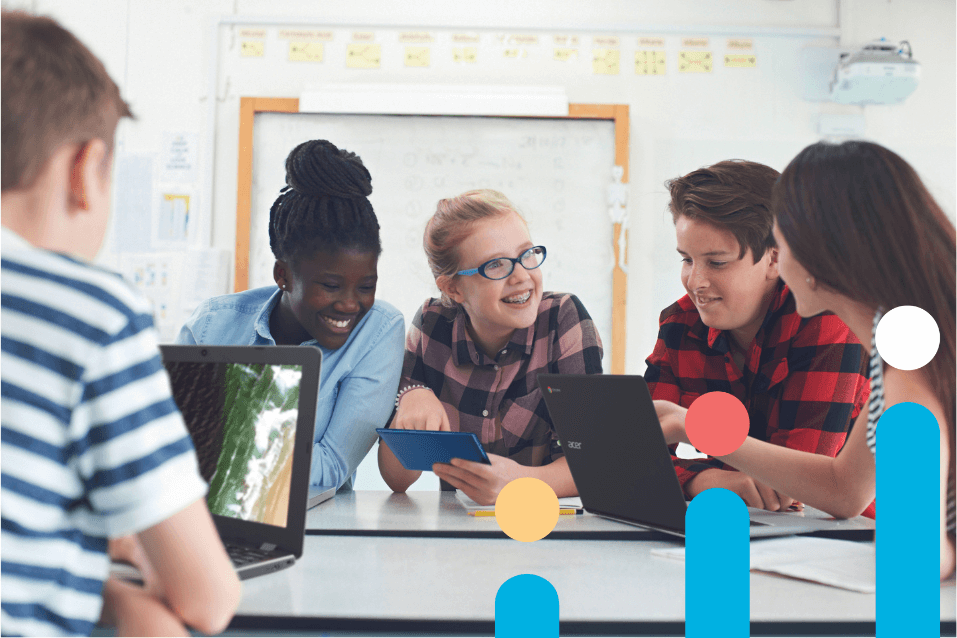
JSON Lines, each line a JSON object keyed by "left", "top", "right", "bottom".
{"left": 160, "top": 346, "right": 322, "bottom": 579}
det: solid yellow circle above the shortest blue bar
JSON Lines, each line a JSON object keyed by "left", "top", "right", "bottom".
{"left": 495, "top": 477, "right": 558, "bottom": 543}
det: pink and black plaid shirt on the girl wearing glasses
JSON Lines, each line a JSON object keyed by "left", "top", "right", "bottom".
{"left": 399, "top": 292, "right": 602, "bottom": 467}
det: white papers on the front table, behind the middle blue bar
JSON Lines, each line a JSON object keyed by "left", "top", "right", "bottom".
{"left": 651, "top": 536, "right": 876, "bottom": 594}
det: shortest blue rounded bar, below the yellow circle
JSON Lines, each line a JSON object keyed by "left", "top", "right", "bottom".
{"left": 495, "top": 574, "right": 558, "bottom": 638}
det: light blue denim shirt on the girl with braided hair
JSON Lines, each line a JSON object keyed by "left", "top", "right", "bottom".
{"left": 176, "top": 286, "right": 405, "bottom": 489}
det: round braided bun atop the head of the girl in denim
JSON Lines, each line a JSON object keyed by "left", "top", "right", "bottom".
{"left": 286, "top": 140, "right": 372, "bottom": 197}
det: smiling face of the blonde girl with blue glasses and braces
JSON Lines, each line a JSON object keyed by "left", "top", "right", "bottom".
{"left": 444, "top": 213, "right": 542, "bottom": 356}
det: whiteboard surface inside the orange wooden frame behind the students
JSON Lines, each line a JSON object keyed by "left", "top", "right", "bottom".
{"left": 249, "top": 113, "right": 615, "bottom": 371}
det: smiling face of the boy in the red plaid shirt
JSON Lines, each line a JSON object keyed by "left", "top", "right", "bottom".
{"left": 675, "top": 215, "right": 777, "bottom": 338}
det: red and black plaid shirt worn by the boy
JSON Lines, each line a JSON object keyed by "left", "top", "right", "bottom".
{"left": 645, "top": 282, "right": 873, "bottom": 514}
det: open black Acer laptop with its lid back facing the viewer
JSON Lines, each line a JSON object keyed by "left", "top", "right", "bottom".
{"left": 538, "top": 374, "right": 860, "bottom": 538}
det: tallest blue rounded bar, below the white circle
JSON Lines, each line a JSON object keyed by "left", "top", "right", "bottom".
{"left": 876, "top": 403, "right": 940, "bottom": 638}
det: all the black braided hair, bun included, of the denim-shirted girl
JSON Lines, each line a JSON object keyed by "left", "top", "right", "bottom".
{"left": 269, "top": 140, "right": 382, "bottom": 262}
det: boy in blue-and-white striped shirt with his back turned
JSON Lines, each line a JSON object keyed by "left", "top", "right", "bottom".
{"left": 0, "top": 11, "right": 240, "bottom": 635}
